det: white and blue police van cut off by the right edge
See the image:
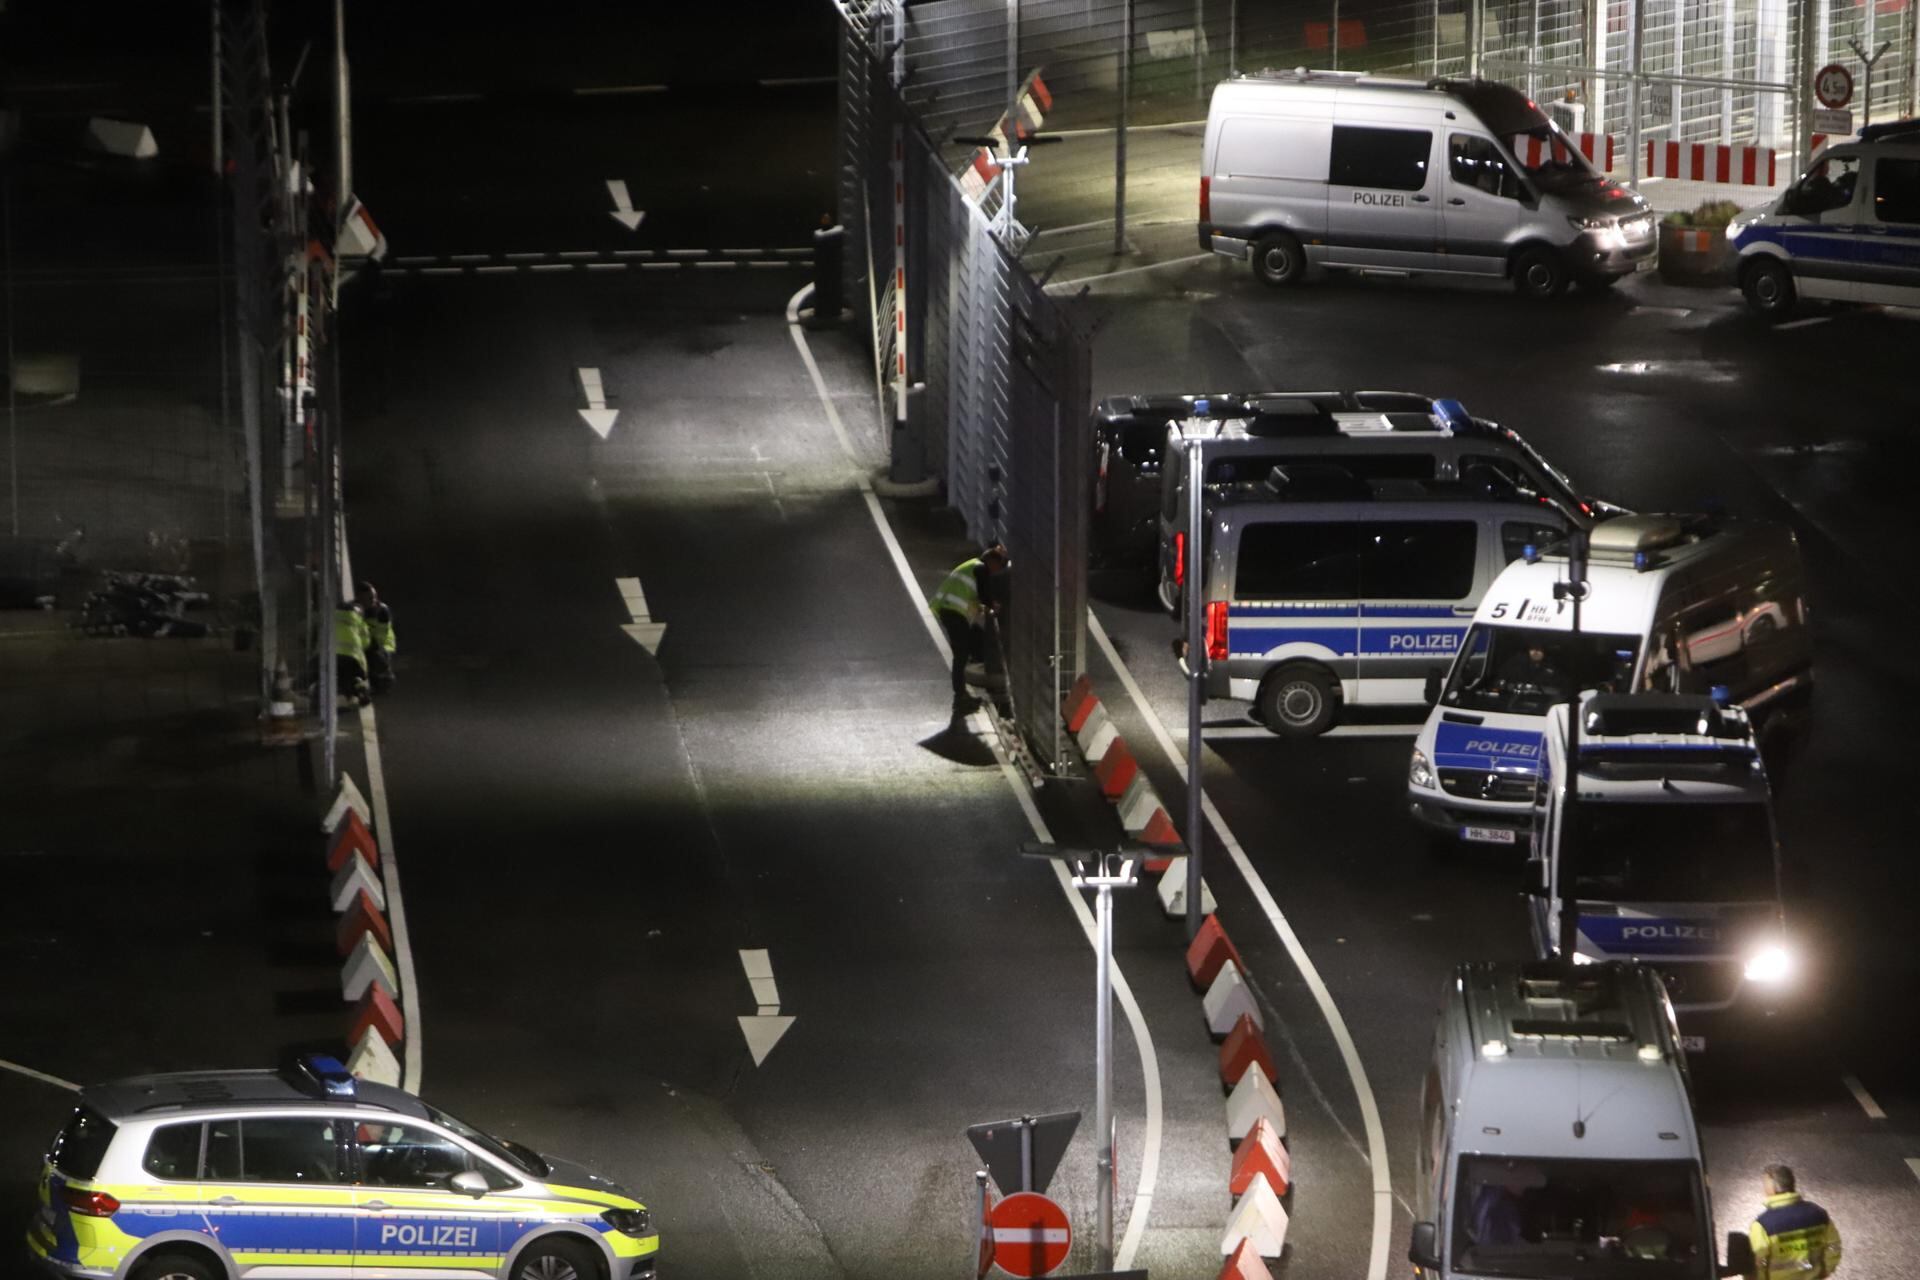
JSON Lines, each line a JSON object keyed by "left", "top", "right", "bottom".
{"left": 1726, "top": 119, "right": 1920, "bottom": 317}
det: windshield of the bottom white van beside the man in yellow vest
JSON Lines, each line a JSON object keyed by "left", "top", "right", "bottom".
{"left": 1450, "top": 1155, "right": 1715, "bottom": 1280}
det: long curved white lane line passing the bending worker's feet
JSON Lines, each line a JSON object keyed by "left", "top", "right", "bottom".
{"left": 787, "top": 284, "right": 1165, "bottom": 1270}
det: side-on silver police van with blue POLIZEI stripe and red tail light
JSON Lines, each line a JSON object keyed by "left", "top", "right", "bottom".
{"left": 1206, "top": 487, "right": 1567, "bottom": 737}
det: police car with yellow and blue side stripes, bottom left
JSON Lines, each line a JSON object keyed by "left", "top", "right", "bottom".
{"left": 27, "top": 1055, "right": 660, "bottom": 1280}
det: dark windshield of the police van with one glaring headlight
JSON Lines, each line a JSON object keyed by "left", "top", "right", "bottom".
{"left": 1574, "top": 800, "right": 1780, "bottom": 902}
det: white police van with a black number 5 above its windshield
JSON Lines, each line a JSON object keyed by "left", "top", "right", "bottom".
{"left": 1407, "top": 516, "right": 1812, "bottom": 846}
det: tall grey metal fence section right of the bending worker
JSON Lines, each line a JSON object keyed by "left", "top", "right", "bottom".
{"left": 833, "top": 0, "right": 1091, "bottom": 768}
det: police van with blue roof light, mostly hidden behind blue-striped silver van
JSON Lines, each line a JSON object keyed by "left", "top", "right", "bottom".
{"left": 1160, "top": 391, "right": 1620, "bottom": 614}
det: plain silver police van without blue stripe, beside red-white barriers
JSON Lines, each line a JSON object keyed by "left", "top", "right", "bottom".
{"left": 1200, "top": 69, "right": 1659, "bottom": 297}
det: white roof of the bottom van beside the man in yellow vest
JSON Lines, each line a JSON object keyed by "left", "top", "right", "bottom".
{"left": 1455, "top": 961, "right": 1699, "bottom": 1159}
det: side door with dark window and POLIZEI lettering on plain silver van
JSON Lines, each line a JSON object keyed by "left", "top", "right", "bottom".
{"left": 1327, "top": 125, "right": 1440, "bottom": 271}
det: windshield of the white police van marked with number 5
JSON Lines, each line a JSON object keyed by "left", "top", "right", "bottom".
{"left": 1440, "top": 622, "right": 1640, "bottom": 716}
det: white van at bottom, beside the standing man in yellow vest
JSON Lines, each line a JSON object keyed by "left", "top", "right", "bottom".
{"left": 1407, "top": 961, "right": 1749, "bottom": 1280}
